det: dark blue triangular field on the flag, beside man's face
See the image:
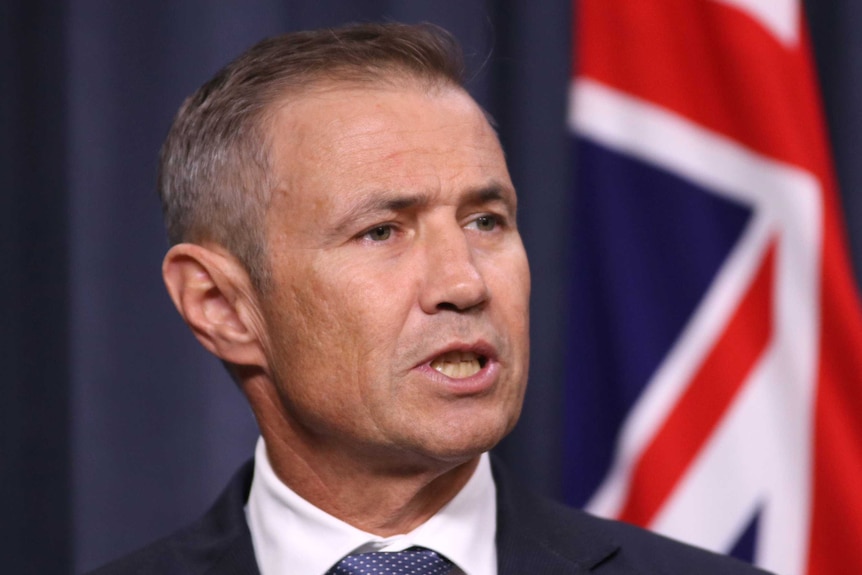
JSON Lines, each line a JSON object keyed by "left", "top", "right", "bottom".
{"left": 564, "top": 138, "right": 751, "bottom": 505}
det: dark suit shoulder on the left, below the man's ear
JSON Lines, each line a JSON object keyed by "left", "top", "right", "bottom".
{"left": 89, "top": 462, "right": 257, "bottom": 575}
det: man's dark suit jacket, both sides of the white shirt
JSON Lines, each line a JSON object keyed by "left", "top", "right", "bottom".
{"left": 91, "top": 461, "right": 776, "bottom": 575}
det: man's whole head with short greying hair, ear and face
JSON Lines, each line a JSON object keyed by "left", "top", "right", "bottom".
{"left": 162, "top": 25, "right": 530, "bottom": 480}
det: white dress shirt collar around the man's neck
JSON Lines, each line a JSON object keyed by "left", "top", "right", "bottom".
{"left": 246, "top": 438, "right": 497, "bottom": 575}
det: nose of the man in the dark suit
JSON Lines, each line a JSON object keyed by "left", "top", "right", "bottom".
{"left": 420, "top": 225, "right": 490, "bottom": 314}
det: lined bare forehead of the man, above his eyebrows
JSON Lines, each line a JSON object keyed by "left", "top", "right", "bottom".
{"left": 270, "top": 83, "right": 511, "bottom": 213}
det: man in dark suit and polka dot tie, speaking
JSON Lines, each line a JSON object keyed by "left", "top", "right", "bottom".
{"left": 91, "top": 20, "right": 772, "bottom": 575}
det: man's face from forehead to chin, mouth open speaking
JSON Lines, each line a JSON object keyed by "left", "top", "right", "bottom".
{"left": 253, "top": 85, "right": 530, "bottom": 470}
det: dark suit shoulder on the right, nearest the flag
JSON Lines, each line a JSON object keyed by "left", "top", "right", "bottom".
{"left": 494, "top": 460, "right": 765, "bottom": 575}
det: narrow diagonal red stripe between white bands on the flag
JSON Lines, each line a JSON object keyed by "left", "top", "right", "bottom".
{"left": 619, "top": 244, "right": 775, "bottom": 525}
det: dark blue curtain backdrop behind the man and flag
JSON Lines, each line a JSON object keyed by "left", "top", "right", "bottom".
{"left": 0, "top": 0, "right": 862, "bottom": 574}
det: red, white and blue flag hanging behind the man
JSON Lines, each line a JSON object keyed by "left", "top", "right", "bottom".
{"left": 565, "top": 0, "right": 862, "bottom": 575}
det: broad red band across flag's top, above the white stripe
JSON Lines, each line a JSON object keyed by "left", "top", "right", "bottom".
{"left": 576, "top": 0, "right": 823, "bottom": 178}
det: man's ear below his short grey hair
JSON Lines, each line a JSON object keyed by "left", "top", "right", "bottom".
{"left": 162, "top": 243, "right": 266, "bottom": 367}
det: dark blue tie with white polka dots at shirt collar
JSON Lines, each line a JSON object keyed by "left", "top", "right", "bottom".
{"left": 326, "top": 547, "right": 454, "bottom": 575}
